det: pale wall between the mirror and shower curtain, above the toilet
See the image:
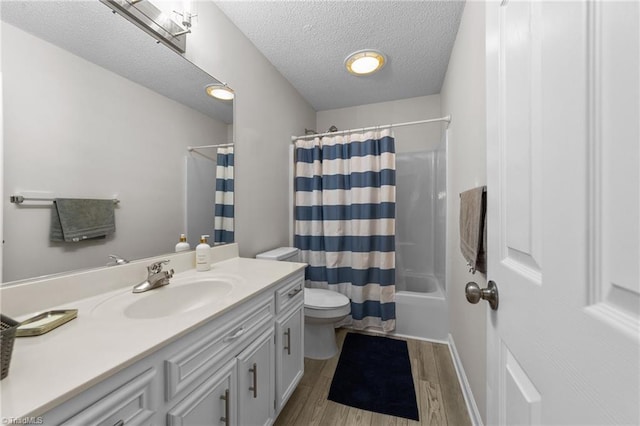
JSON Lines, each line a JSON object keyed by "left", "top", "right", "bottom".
{"left": 186, "top": 0, "right": 316, "bottom": 257}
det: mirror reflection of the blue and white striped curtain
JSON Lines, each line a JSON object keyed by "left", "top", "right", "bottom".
{"left": 213, "top": 147, "right": 234, "bottom": 244}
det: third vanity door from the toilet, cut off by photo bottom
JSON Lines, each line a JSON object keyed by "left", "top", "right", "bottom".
{"left": 167, "top": 359, "right": 238, "bottom": 426}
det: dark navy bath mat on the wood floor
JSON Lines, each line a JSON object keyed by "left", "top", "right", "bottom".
{"left": 329, "top": 333, "right": 418, "bottom": 420}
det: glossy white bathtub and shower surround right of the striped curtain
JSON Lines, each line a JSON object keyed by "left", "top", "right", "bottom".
{"left": 395, "top": 148, "right": 449, "bottom": 342}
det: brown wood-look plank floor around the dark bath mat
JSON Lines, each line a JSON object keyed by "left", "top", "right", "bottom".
{"left": 275, "top": 329, "right": 471, "bottom": 426}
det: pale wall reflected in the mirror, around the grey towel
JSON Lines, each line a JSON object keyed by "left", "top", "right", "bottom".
{"left": 2, "top": 23, "right": 227, "bottom": 282}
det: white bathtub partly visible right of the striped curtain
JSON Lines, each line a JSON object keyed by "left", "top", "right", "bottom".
{"left": 394, "top": 274, "right": 449, "bottom": 342}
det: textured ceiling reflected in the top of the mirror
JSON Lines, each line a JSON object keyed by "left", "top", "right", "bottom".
{"left": 1, "top": 0, "right": 233, "bottom": 123}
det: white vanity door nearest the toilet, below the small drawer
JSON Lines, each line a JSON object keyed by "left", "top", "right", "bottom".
{"left": 276, "top": 306, "right": 304, "bottom": 412}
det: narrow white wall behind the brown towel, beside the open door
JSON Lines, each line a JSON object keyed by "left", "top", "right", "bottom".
{"left": 440, "top": 2, "right": 490, "bottom": 421}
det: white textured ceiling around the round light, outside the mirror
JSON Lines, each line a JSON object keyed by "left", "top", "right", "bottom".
{"left": 214, "top": 0, "right": 464, "bottom": 111}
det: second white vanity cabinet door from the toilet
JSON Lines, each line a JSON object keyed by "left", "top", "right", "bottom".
{"left": 237, "top": 327, "right": 275, "bottom": 426}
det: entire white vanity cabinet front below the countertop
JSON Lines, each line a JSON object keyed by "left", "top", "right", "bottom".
{"left": 35, "top": 271, "right": 304, "bottom": 426}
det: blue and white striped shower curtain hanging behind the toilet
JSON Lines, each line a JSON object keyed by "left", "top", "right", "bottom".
{"left": 295, "top": 130, "right": 396, "bottom": 331}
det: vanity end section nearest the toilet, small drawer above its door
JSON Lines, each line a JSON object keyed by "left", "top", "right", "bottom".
{"left": 276, "top": 274, "right": 304, "bottom": 413}
